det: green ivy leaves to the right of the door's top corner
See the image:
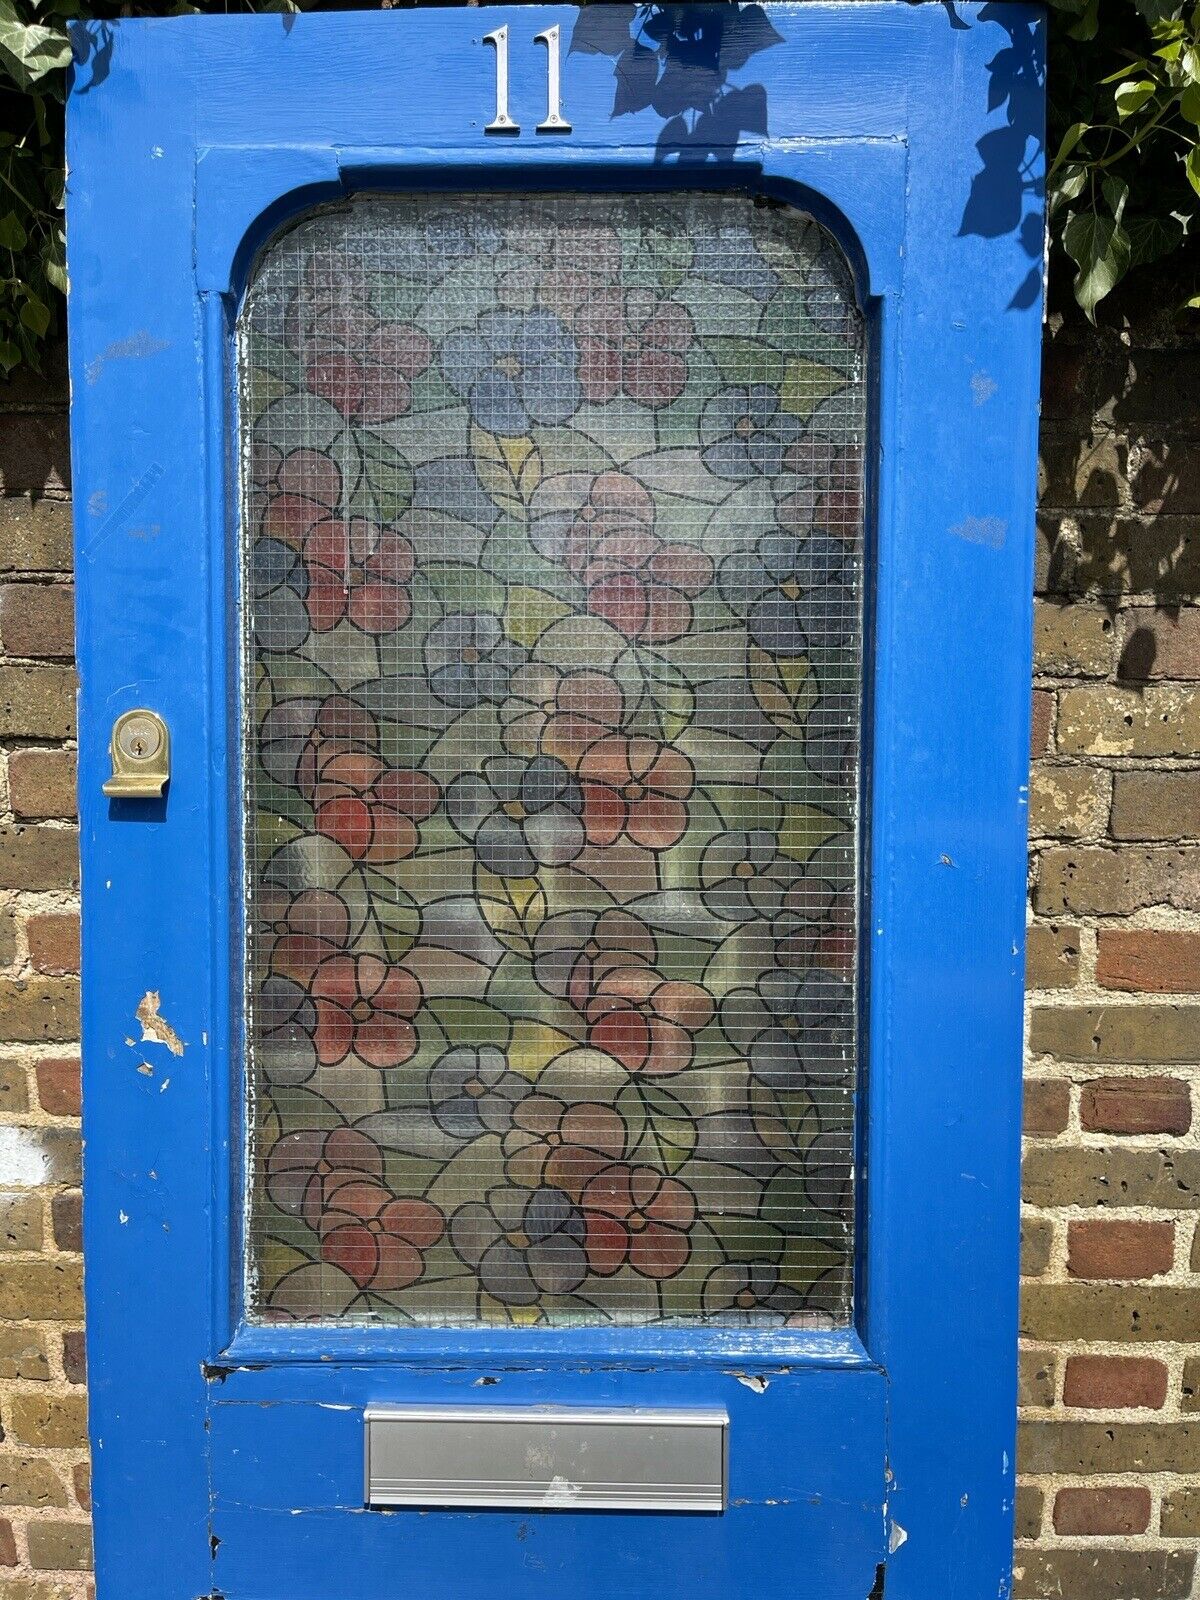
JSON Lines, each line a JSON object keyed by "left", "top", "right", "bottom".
{"left": 1048, "top": 0, "right": 1200, "bottom": 322}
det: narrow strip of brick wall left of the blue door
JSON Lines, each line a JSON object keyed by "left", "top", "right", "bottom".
{"left": 0, "top": 347, "right": 91, "bottom": 1600}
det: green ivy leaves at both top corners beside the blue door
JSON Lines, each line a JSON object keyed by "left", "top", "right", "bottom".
{"left": 0, "top": 0, "right": 1200, "bottom": 373}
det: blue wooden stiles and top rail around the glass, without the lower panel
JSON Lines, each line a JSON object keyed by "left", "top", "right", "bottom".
{"left": 69, "top": 0, "right": 1043, "bottom": 1600}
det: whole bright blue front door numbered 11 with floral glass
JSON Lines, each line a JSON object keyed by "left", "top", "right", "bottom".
{"left": 70, "top": 5, "right": 1040, "bottom": 1600}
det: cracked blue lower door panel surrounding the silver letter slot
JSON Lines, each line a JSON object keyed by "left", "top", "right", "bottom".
{"left": 211, "top": 1368, "right": 886, "bottom": 1600}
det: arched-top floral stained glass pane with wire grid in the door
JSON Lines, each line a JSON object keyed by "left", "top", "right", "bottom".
{"left": 240, "top": 194, "right": 866, "bottom": 1326}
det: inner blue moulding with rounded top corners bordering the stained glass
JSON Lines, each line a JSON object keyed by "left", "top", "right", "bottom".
{"left": 211, "top": 139, "right": 907, "bottom": 1366}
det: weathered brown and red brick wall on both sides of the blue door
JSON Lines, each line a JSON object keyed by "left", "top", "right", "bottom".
{"left": 0, "top": 296, "right": 1200, "bottom": 1600}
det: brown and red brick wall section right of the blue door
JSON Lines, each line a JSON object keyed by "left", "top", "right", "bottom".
{"left": 1014, "top": 296, "right": 1200, "bottom": 1600}
